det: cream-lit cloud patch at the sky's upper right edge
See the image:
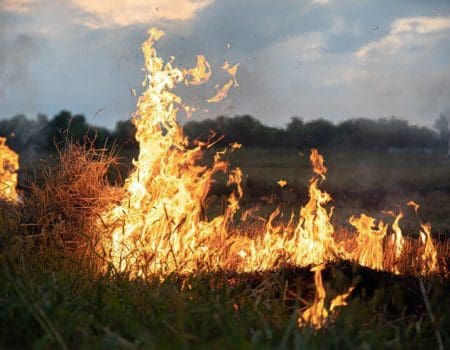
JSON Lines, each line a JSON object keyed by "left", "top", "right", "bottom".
{"left": 356, "top": 17, "right": 450, "bottom": 59}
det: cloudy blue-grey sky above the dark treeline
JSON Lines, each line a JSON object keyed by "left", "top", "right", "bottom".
{"left": 0, "top": 0, "right": 450, "bottom": 128}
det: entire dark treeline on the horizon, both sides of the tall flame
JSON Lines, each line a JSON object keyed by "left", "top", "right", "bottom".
{"left": 0, "top": 111, "right": 449, "bottom": 153}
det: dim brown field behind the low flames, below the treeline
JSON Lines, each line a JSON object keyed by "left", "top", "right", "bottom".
{"left": 224, "top": 149, "right": 450, "bottom": 236}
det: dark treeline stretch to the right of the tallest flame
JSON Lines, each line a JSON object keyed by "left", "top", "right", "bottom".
{"left": 185, "top": 115, "right": 449, "bottom": 151}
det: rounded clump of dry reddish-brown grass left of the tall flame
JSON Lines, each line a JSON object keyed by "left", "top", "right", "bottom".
{"left": 18, "top": 142, "right": 121, "bottom": 270}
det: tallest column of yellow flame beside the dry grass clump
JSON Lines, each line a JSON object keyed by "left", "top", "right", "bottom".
{"left": 103, "top": 28, "right": 237, "bottom": 276}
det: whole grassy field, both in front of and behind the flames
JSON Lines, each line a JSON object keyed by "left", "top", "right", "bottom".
{"left": 0, "top": 149, "right": 450, "bottom": 349}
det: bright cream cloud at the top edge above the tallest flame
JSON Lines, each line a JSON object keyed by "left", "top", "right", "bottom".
{"left": 72, "top": 0, "right": 213, "bottom": 28}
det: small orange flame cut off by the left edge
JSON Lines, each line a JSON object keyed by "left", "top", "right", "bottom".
{"left": 0, "top": 137, "right": 19, "bottom": 201}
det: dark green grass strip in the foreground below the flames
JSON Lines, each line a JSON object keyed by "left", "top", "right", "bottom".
{"left": 0, "top": 250, "right": 450, "bottom": 349}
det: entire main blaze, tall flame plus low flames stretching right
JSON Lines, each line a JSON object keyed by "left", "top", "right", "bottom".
{"left": 102, "top": 28, "right": 439, "bottom": 328}
